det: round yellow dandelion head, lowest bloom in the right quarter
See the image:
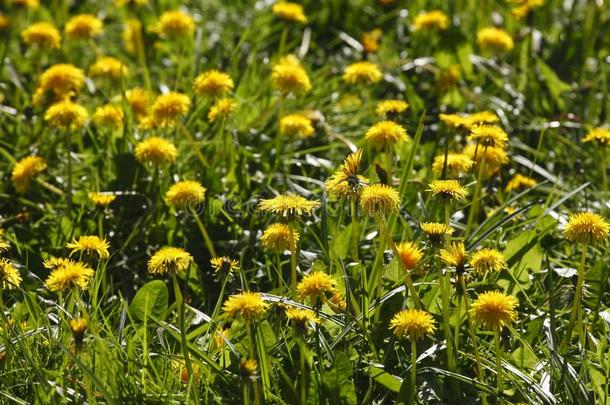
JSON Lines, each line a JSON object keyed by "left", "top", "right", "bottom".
{"left": 470, "top": 291, "right": 519, "bottom": 331}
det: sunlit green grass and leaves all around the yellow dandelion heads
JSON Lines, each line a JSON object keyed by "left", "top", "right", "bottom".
{"left": 0, "top": 0, "right": 610, "bottom": 404}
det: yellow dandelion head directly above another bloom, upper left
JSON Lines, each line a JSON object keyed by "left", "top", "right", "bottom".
{"left": 34, "top": 63, "right": 85, "bottom": 104}
